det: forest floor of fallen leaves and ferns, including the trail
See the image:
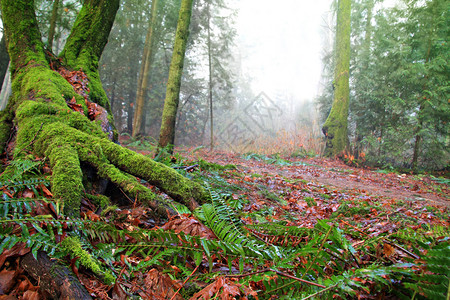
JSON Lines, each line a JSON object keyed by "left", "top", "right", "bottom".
{"left": 0, "top": 141, "right": 450, "bottom": 300}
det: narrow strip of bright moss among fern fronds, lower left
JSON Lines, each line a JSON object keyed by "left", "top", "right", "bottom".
{"left": 60, "top": 237, "right": 116, "bottom": 285}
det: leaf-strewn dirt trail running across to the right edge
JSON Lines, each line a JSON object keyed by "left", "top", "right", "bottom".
{"left": 182, "top": 150, "right": 450, "bottom": 207}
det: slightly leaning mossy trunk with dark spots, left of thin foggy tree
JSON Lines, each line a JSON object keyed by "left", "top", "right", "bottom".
{"left": 158, "top": 0, "right": 193, "bottom": 152}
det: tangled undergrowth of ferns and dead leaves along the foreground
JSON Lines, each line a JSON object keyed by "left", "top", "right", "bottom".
{"left": 0, "top": 155, "right": 450, "bottom": 299}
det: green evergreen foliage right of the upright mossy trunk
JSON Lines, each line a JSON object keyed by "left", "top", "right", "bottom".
{"left": 318, "top": 0, "right": 450, "bottom": 171}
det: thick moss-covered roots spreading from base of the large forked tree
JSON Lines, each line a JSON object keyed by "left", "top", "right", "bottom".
{"left": 34, "top": 122, "right": 208, "bottom": 217}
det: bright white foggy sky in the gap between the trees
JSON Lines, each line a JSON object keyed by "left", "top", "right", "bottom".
{"left": 236, "top": 0, "right": 331, "bottom": 100}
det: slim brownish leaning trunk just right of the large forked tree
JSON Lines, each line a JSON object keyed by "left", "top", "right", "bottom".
{"left": 132, "top": 0, "right": 158, "bottom": 137}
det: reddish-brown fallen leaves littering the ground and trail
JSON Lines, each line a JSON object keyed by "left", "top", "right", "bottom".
{"left": 0, "top": 145, "right": 450, "bottom": 299}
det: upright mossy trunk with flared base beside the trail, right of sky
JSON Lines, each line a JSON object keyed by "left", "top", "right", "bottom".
{"left": 322, "top": 0, "right": 351, "bottom": 156}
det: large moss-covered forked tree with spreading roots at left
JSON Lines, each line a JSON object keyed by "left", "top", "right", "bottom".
{"left": 0, "top": 0, "right": 207, "bottom": 216}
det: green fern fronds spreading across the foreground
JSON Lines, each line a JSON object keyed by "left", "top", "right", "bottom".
{"left": 0, "top": 156, "right": 450, "bottom": 299}
